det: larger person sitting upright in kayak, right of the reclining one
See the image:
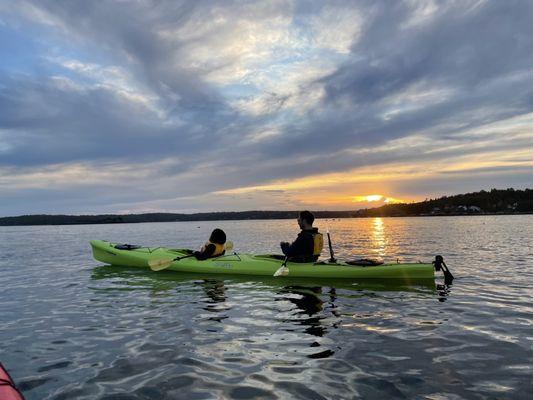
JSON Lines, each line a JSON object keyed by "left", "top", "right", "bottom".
{"left": 280, "top": 211, "right": 324, "bottom": 262}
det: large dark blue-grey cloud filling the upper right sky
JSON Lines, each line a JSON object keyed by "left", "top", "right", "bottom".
{"left": 264, "top": 2, "right": 533, "bottom": 157}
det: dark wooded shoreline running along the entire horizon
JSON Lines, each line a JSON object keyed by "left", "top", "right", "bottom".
{"left": 0, "top": 189, "right": 533, "bottom": 226}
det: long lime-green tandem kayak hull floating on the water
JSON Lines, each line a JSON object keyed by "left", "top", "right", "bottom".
{"left": 90, "top": 240, "right": 444, "bottom": 281}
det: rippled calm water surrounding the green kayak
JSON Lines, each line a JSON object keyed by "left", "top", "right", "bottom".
{"left": 0, "top": 215, "right": 533, "bottom": 400}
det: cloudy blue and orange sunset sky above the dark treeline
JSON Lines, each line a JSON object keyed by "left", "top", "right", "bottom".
{"left": 0, "top": 0, "right": 533, "bottom": 216}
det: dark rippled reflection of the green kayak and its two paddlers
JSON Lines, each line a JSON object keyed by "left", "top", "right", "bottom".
{"left": 92, "top": 266, "right": 442, "bottom": 358}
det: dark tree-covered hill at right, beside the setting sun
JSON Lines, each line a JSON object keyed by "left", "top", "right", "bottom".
{"left": 356, "top": 188, "right": 533, "bottom": 217}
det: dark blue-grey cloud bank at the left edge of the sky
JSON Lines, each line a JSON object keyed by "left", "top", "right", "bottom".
{"left": 0, "top": 74, "right": 187, "bottom": 166}
